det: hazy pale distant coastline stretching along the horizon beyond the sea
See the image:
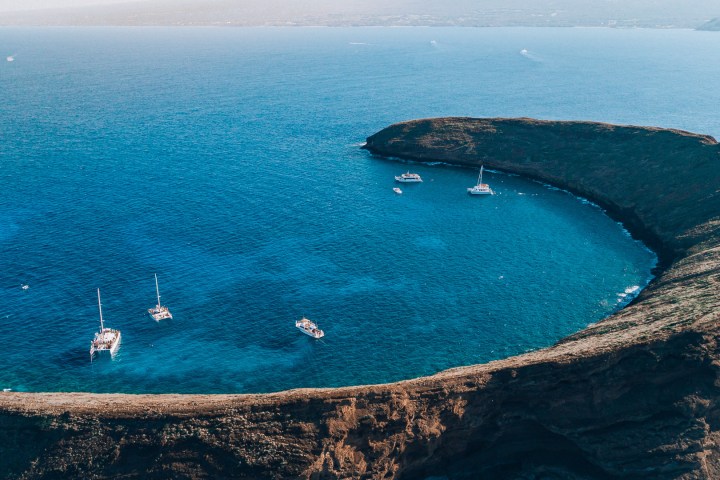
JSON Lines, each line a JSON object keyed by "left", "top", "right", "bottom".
{"left": 0, "top": 0, "right": 720, "bottom": 28}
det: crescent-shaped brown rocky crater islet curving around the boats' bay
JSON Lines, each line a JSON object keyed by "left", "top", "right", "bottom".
{"left": 0, "top": 118, "right": 720, "bottom": 479}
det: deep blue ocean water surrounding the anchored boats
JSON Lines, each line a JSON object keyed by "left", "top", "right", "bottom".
{"left": 0, "top": 28, "right": 720, "bottom": 393}
